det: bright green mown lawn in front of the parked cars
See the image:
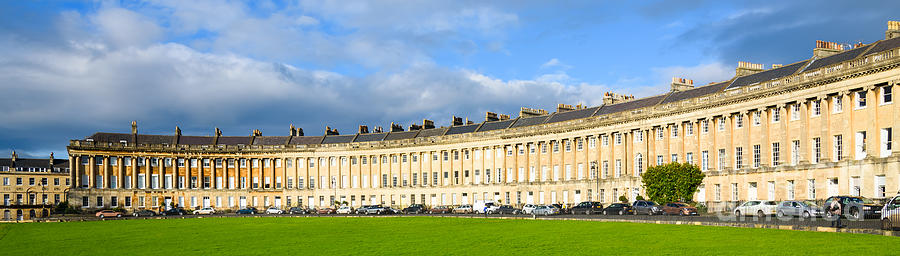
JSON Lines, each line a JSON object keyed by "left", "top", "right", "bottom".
{"left": 0, "top": 217, "right": 900, "bottom": 255}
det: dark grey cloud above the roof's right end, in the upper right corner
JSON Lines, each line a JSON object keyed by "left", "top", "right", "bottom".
{"left": 678, "top": 1, "right": 900, "bottom": 64}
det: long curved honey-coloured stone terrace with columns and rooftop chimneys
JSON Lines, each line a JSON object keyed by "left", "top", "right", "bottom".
{"left": 58, "top": 21, "right": 900, "bottom": 213}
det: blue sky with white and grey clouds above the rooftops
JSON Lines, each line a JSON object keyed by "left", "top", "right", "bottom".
{"left": 0, "top": 0, "right": 900, "bottom": 157}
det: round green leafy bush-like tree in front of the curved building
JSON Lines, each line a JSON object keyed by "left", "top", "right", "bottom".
{"left": 641, "top": 163, "right": 706, "bottom": 203}
